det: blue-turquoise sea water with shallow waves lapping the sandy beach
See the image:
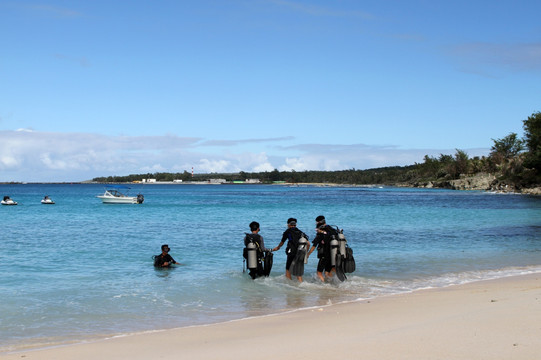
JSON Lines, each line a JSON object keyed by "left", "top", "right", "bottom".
{"left": 0, "top": 184, "right": 541, "bottom": 353}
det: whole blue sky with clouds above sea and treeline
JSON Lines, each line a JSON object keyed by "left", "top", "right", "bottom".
{"left": 0, "top": 0, "right": 541, "bottom": 182}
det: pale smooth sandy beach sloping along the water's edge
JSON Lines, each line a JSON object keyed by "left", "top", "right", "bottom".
{"left": 5, "top": 274, "right": 541, "bottom": 360}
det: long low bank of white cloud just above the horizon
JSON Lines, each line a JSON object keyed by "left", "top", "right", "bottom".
{"left": 0, "top": 131, "right": 488, "bottom": 182}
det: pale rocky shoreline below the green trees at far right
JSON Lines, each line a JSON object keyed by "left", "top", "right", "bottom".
{"left": 406, "top": 173, "right": 541, "bottom": 195}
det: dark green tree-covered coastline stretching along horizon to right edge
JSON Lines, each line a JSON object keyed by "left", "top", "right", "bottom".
{"left": 93, "top": 112, "right": 541, "bottom": 191}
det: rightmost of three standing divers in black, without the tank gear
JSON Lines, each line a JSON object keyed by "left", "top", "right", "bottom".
{"left": 308, "top": 215, "right": 338, "bottom": 281}
